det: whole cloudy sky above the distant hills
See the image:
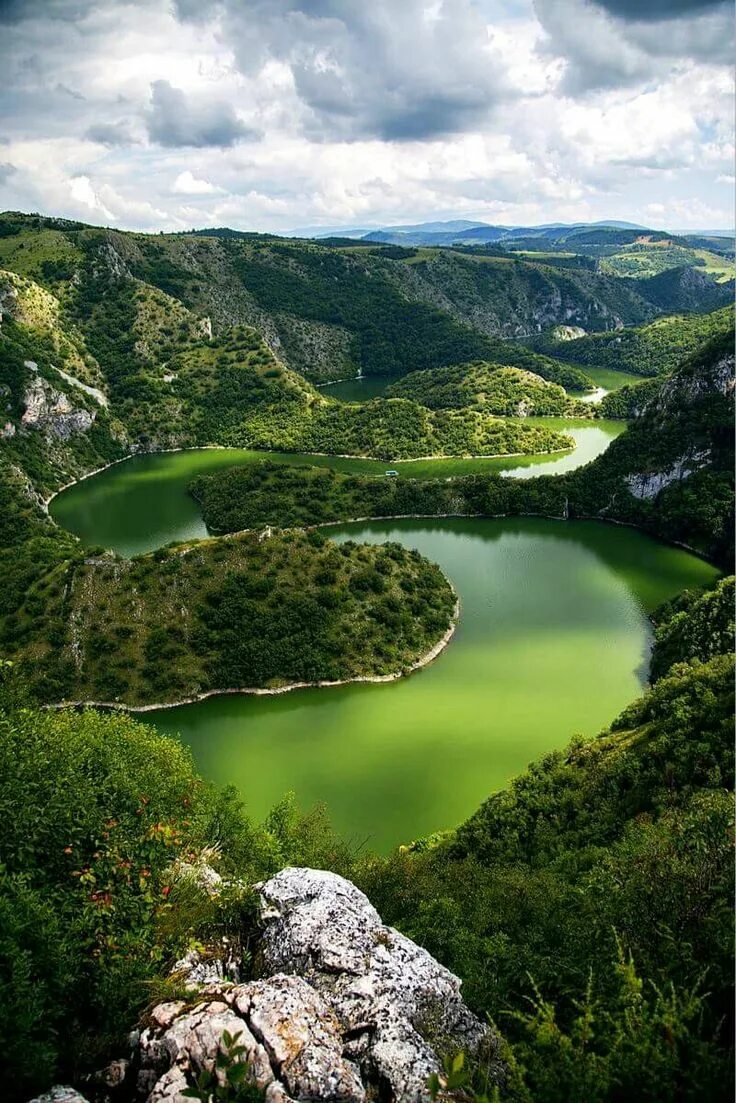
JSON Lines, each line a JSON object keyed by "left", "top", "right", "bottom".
{"left": 0, "top": 0, "right": 734, "bottom": 232}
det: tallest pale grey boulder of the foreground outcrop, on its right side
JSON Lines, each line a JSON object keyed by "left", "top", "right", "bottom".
{"left": 256, "top": 868, "right": 502, "bottom": 1103}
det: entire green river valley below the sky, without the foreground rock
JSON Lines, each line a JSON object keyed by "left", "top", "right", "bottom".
{"left": 0, "top": 214, "right": 733, "bottom": 1103}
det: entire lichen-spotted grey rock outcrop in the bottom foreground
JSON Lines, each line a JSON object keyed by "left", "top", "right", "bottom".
{"left": 31, "top": 868, "right": 503, "bottom": 1103}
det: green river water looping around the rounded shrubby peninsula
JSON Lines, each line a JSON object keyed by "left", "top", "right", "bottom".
{"left": 51, "top": 436, "right": 716, "bottom": 850}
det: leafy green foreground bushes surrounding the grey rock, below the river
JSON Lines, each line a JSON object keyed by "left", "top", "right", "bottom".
{"left": 0, "top": 582, "right": 733, "bottom": 1103}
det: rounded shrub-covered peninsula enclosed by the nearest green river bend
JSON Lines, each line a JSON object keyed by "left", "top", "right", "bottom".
{"left": 3, "top": 533, "right": 455, "bottom": 705}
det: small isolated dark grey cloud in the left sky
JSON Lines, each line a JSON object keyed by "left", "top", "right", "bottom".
{"left": 147, "top": 81, "right": 258, "bottom": 149}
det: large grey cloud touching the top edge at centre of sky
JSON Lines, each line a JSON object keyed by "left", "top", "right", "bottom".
{"left": 178, "top": 0, "right": 513, "bottom": 141}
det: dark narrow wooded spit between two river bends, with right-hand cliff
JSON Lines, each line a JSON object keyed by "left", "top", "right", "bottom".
{"left": 191, "top": 326, "right": 734, "bottom": 568}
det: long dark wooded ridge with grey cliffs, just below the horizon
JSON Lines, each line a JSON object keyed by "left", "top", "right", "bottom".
{"left": 0, "top": 213, "right": 727, "bottom": 392}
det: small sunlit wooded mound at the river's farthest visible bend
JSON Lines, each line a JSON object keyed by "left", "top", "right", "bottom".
{"left": 386, "top": 361, "right": 595, "bottom": 417}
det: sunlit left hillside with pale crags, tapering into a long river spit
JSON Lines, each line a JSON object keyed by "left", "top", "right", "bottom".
{"left": 0, "top": 260, "right": 575, "bottom": 494}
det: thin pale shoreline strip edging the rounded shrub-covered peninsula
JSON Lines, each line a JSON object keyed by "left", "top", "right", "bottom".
{"left": 45, "top": 595, "right": 460, "bottom": 713}
